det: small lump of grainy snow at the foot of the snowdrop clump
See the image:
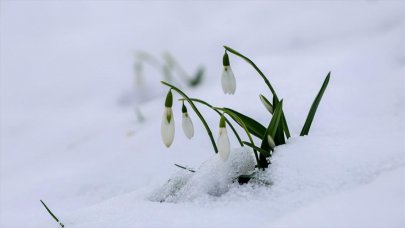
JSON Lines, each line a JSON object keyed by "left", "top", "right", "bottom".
{"left": 149, "top": 147, "right": 255, "bottom": 203}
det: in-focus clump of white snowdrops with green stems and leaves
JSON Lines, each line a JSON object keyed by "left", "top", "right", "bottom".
{"left": 162, "top": 46, "right": 330, "bottom": 173}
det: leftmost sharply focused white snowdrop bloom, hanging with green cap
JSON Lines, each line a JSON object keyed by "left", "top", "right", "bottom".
{"left": 161, "top": 90, "right": 174, "bottom": 147}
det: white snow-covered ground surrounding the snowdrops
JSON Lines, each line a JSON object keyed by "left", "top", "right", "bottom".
{"left": 0, "top": 1, "right": 405, "bottom": 227}
